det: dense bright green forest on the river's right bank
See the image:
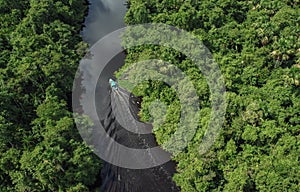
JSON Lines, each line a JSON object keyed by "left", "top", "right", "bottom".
{"left": 122, "top": 0, "right": 300, "bottom": 192}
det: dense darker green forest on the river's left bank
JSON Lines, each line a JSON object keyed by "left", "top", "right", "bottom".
{"left": 0, "top": 0, "right": 101, "bottom": 192}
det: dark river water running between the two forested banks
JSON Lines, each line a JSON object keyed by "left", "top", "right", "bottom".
{"left": 82, "top": 0, "right": 179, "bottom": 192}
